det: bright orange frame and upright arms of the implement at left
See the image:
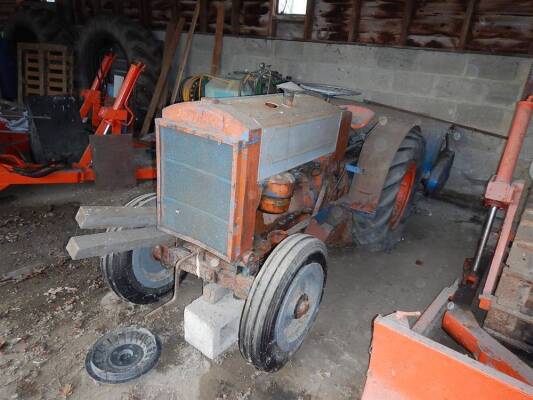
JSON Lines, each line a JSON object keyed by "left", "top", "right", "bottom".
{"left": 0, "top": 55, "right": 157, "bottom": 190}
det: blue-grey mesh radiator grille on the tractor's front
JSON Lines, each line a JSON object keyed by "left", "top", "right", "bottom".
{"left": 159, "top": 127, "right": 233, "bottom": 255}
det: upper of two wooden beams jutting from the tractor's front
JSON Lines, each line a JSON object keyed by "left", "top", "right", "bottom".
{"left": 76, "top": 206, "right": 157, "bottom": 229}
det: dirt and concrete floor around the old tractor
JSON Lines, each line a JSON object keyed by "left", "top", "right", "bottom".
{"left": 0, "top": 184, "right": 480, "bottom": 400}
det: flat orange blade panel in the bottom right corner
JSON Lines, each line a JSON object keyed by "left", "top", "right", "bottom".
{"left": 362, "top": 316, "right": 533, "bottom": 400}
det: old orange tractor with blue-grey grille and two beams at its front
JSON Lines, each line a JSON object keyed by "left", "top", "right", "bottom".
{"left": 67, "top": 92, "right": 451, "bottom": 371}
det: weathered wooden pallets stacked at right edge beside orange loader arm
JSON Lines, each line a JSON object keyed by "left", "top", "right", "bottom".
{"left": 484, "top": 192, "right": 533, "bottom": 353}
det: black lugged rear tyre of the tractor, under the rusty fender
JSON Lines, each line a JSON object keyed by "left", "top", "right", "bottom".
{"left": 352, "top": 127, "right": 425, "bottom": 251}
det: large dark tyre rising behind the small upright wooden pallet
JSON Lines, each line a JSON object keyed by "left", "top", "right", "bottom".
{"left": 4, "top": 4, "right": 74, "bottom": 55}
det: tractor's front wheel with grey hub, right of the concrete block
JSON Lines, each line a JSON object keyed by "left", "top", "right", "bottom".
{"left": 239, "top": 234, "right": 327, "bottom": 371}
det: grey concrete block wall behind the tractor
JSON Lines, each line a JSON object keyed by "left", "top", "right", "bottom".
{"left": 164, "top": 34, "right": 533, "bottom": 194}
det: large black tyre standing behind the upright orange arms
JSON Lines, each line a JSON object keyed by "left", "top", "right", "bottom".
{"left": 76, "top": 15, "right": 162, "bottom": 128}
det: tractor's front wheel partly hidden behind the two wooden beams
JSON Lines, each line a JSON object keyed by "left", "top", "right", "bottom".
{"left": 101, "top": 193, "right": 174, "bottom": 304}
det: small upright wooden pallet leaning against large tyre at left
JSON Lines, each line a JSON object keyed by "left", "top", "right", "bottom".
{"left": 17, "top": 43, "right": 74, "bottom": 102}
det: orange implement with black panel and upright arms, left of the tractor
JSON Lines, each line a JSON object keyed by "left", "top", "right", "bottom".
{"left": 0, "top": 54, "right": 156, "bottom": 190}
